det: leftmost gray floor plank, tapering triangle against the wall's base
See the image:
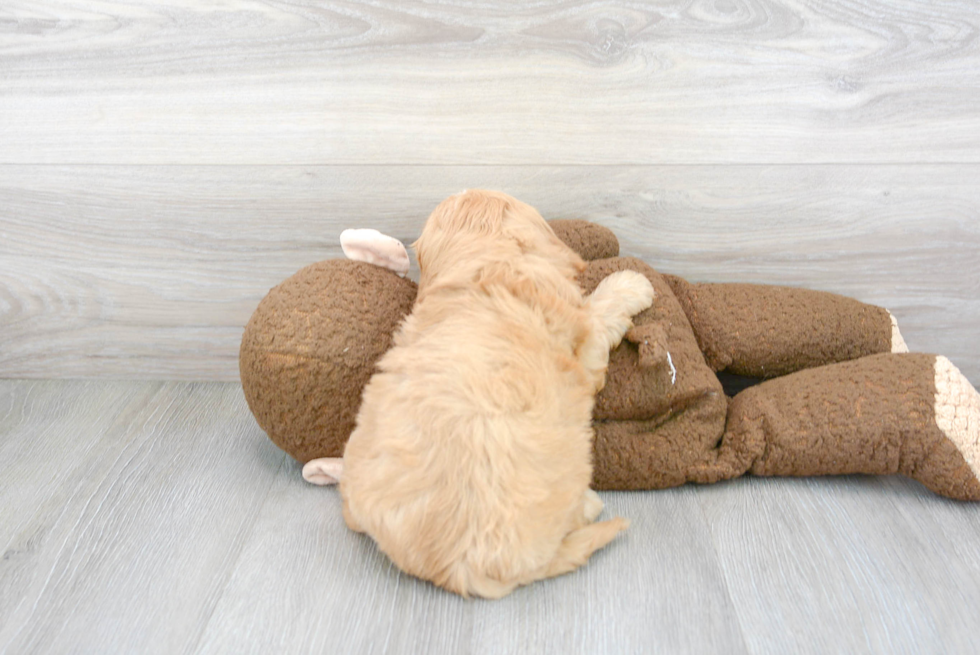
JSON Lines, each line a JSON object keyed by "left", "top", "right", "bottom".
{"left": 0, "top": 381, "right": 159, "bottom": 628}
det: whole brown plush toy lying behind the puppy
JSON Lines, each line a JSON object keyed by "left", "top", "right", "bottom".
{"left": 240, "top": 221, "right": 980, "bottom": 500}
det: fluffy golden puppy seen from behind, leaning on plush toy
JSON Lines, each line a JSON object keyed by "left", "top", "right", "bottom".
{"left": 340, "top": 191, "right": 653, "bottom": 598}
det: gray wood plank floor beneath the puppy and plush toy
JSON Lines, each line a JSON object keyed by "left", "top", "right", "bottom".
{"left": 0, "top": 380, "right": 980, "bottom": 654}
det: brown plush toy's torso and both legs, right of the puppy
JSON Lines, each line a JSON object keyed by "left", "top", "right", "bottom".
{"left": 585, "top": 258, "right": 980, "bottom": 500}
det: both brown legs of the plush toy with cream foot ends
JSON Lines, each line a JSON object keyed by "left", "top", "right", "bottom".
{"left": 666, "top": 276, "right": 980, "bottom": 500}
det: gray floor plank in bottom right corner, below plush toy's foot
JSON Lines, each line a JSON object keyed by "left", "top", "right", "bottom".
{"left": 700, "top": 476, "right": 980, "bottom": 653}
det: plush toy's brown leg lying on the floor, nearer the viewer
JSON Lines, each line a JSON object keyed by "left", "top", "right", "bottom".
{"left": 708, "top": 353, "right": 980, "bottom": 500}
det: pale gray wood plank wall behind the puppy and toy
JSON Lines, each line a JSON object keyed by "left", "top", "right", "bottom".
{"left": 0, "top": 0, "right": 980, "bottom": 384}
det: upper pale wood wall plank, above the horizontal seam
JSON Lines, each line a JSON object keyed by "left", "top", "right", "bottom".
{"left": 0, "top": 0, "right": 980, "bottom": 165}
